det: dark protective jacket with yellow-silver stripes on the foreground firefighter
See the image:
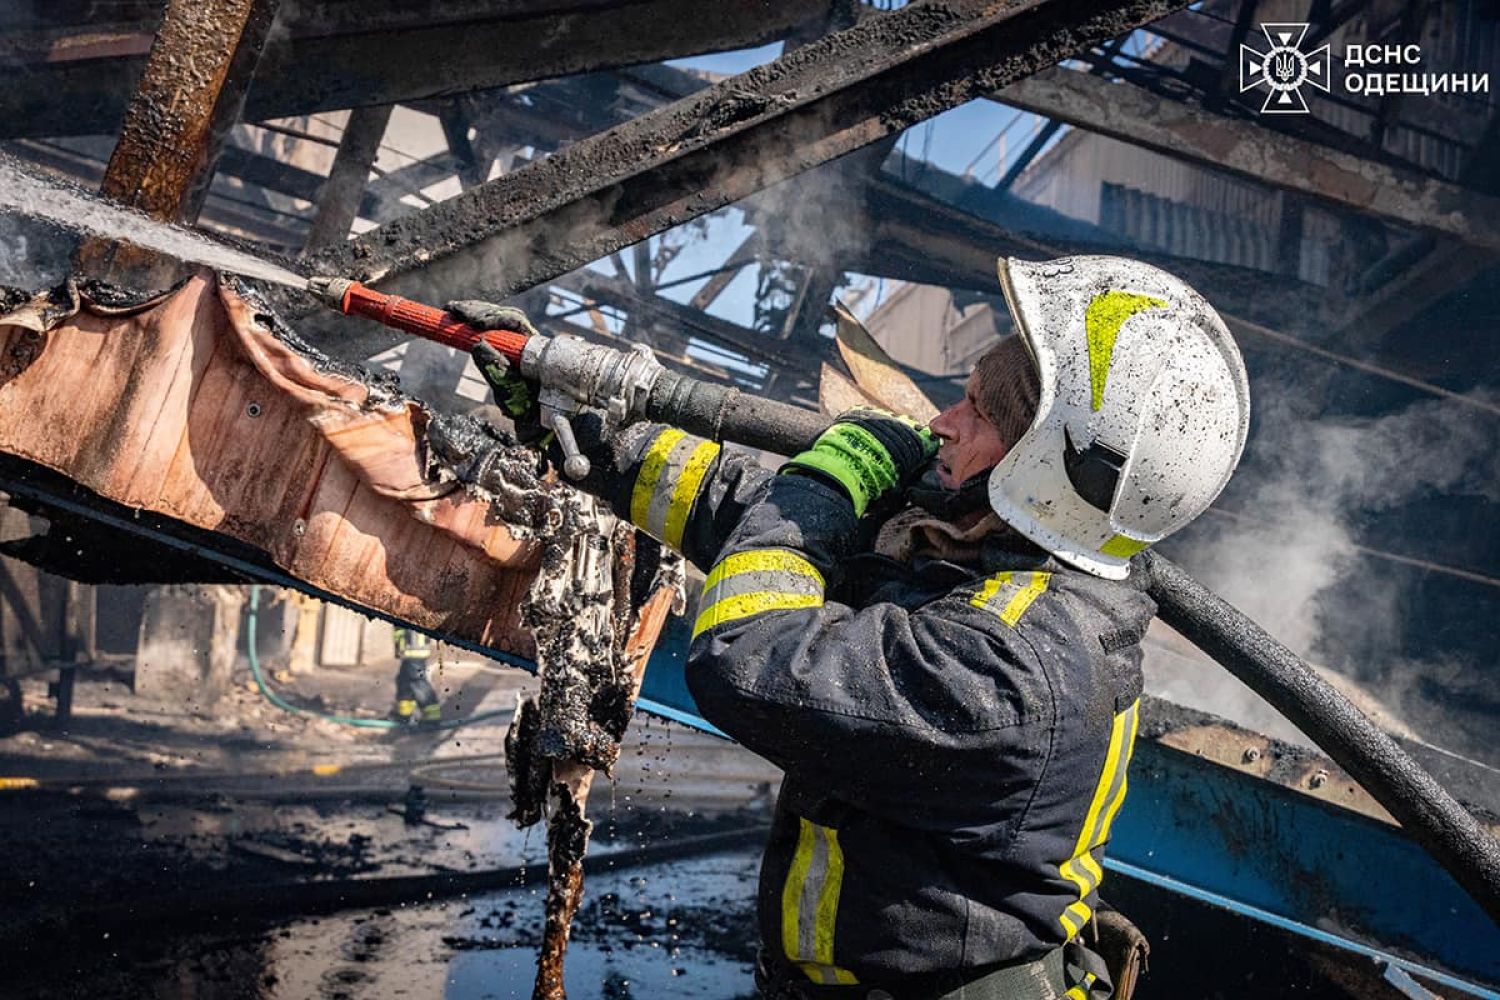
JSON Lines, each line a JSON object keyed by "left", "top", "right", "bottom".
{"left": 587, "top": 424, "right": 1155, "bottom": 996}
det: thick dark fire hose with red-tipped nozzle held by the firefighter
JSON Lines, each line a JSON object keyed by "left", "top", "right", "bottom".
{"left": 308, "top": 277, "right": 1500, "bottom": 924}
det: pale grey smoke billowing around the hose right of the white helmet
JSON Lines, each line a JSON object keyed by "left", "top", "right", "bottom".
{"left": 1148, "top": 371, "right": 1500, "bottom": 757}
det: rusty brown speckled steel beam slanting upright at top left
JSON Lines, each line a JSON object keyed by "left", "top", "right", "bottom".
{"left": 99, "top": 0, "right": 281, "bottom": 222}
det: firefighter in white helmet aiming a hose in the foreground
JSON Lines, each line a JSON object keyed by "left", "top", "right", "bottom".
{"left": 462, "top": 256, "right": 1250, "bottom": 1000}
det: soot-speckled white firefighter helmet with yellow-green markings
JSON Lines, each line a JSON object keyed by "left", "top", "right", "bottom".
{"left": 990, "top": 256, "right": 1250, "bottom": 580}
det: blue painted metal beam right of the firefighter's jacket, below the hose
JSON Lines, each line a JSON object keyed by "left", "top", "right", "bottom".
{"left": 1110, "top": 741, "right": 1500, "bottom": 985}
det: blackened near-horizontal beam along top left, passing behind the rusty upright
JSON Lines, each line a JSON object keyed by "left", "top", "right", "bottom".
{"left": 0, "top": 0, "right": 830, "bottom": 138}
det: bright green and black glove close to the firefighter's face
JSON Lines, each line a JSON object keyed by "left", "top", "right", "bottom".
{"left": 782, "top": 409, "right": 939, "bottom": 517}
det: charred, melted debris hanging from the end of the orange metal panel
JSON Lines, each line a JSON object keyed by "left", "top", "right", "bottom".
{"left": 429, "top": 420, "right": 683, "bottom": 1000}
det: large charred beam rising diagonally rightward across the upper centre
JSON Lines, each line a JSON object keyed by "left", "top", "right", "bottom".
{"left": 307, "top": 0, "right": 1185, "bottom": 307}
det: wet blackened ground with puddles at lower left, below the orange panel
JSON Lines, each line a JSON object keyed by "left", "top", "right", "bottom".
{"left": 0, "top": 653, "right": 776, "bottom": 1000}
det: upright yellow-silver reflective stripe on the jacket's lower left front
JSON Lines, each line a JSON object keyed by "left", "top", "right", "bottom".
{"left": 782, "top": 817, "right": 858, "bottom": 985}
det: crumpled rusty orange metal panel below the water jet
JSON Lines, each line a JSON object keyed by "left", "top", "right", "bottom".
{"left": 0, "top": 274, "right": 537, "bottom": 655}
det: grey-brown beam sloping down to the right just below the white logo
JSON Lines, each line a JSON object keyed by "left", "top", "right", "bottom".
{"left": 999, "top": 70, "right": 1500, "bottom": 250}
